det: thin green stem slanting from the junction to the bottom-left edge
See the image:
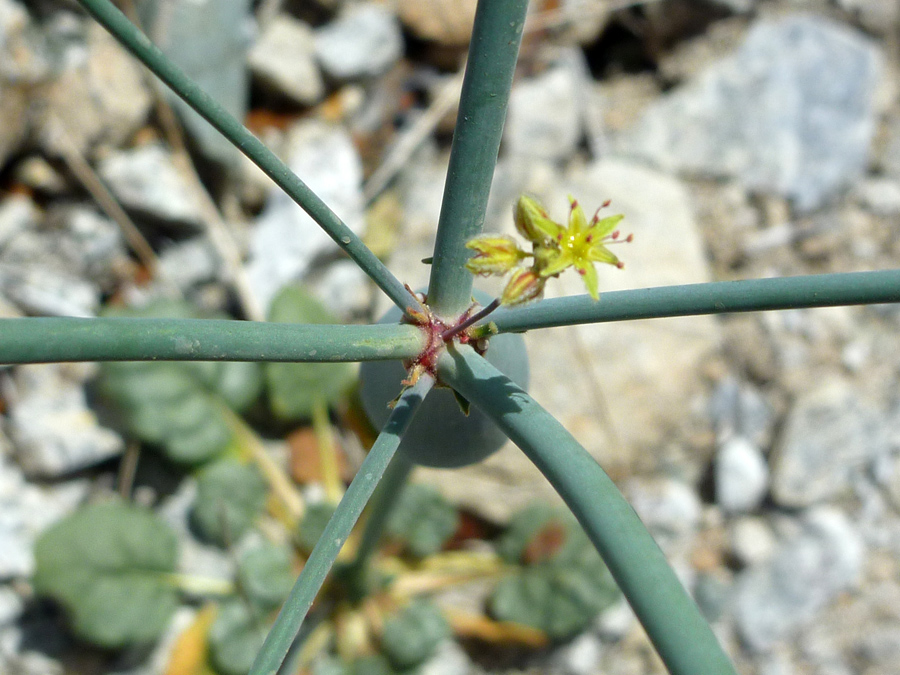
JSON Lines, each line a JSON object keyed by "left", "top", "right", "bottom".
{"left": 249, "top": 376, "right": 434, "bottom": 675}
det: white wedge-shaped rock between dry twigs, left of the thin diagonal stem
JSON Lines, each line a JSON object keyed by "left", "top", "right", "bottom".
{"left": 97, "top": 144, "right": 203, "bottom": 229}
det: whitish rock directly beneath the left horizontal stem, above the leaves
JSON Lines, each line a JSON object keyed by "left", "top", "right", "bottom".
{"left": 9, "top": 364, "right": 124, "bottom": 478}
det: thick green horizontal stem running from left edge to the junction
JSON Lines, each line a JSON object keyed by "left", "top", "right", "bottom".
{"left": 0, "top": 317, "right": 423, "bottom": 363}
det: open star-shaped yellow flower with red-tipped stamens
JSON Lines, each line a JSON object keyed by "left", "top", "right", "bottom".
{"left": 535, "top": 196, "right": 631, "bottom": 300}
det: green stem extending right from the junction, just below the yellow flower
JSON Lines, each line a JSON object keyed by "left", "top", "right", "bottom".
{"left": 491, "top": 270, "right": 900, "bottom": 333}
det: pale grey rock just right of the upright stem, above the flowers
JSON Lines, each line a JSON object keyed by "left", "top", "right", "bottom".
{"left": 504, "top": 49, "right": 587, "bottom": 161}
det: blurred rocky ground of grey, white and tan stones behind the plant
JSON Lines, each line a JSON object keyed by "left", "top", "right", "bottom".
{"left": 0, "top": 0, "right": 900, "bottom": 675}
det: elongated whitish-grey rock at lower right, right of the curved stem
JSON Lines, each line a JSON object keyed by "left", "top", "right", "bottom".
{"left": 735, "top": 507, "right": 865, "bottom": 652}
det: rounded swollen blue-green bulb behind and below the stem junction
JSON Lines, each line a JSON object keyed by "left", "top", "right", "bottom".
{"left": 359, "top": 291, "right": 528, "bottom": 469}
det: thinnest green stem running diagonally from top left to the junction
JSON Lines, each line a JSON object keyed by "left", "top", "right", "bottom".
{"left": 78, "top": 0, "right": 419, "bottom": 311}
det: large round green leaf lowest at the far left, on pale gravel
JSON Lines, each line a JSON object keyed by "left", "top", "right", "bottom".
{"left": 34, "top": 502, "right": 178, "bottom": 647}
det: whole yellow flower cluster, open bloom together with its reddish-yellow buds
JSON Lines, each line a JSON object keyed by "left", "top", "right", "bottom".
{"left": 466, "top": 195, "right": 632, "bottom": 305}
